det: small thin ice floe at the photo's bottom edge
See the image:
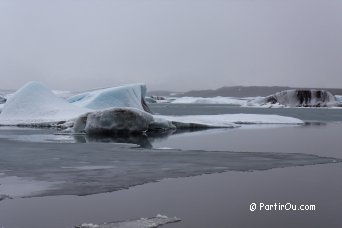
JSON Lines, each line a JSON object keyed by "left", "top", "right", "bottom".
{"left": 76, "top": 215, "right": 181, "bottom": 228}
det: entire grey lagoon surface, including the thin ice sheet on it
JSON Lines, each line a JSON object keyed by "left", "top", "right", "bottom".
{"left": 0, "top": 104, "right": 342, "bottom": 228}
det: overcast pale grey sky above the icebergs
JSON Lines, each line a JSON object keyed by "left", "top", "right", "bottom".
{"left": 0, "top": 0, "right": 342, "bottom": 91}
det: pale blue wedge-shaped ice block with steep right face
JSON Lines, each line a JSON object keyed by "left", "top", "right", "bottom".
{"left": 68, "top": 84, "right": 150, "bottom": 112}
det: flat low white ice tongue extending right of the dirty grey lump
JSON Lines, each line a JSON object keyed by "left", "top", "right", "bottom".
{"left": 157, "top": 114, "right": 304, "bottom": 128}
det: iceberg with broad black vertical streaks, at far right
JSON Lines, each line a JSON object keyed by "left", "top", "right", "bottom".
{"left": 255, "top": 89, "right": 336, "bottom": 107}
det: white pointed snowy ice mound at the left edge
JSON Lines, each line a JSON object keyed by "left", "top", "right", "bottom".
{"left": 0, "top": 82, "right": 89, "bottom": 125}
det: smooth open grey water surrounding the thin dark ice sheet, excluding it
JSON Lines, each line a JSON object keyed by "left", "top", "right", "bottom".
{"left": 0, "top": 105, "right": 342, "bottom": 228}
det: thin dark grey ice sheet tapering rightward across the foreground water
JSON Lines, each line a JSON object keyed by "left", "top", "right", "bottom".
{"left": 0, "top": 139, "right": 340, "bottom": 198}
